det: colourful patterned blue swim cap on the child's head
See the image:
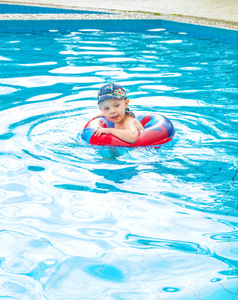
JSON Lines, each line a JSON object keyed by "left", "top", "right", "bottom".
{"left": 98, "top": 83, "right": 126, "bottom": 104}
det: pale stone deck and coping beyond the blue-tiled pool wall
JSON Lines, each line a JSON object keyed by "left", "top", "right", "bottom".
{"left": 0, "top": 0, "right": 238, "bottom": 30}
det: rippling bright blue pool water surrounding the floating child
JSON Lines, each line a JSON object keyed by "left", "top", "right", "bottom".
{"left": 0, "top": 30, "right": 238, "bottom": 300}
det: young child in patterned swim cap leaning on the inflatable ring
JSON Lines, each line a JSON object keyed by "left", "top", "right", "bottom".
{"left": 94, "top": 83, "right": 144, "bottom": 143}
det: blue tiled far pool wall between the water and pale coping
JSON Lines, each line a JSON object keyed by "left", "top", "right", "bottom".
{"left": 0, "top": 19, "right": 238, "bottom": 46}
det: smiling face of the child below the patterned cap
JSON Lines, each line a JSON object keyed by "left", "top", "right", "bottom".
{"left": 99, "top": 99, "right": 129, "bottom": 123}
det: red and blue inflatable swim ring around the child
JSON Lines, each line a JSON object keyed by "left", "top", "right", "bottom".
{"left": 82, "top": 114, "right": 175, "bottom": 147}
